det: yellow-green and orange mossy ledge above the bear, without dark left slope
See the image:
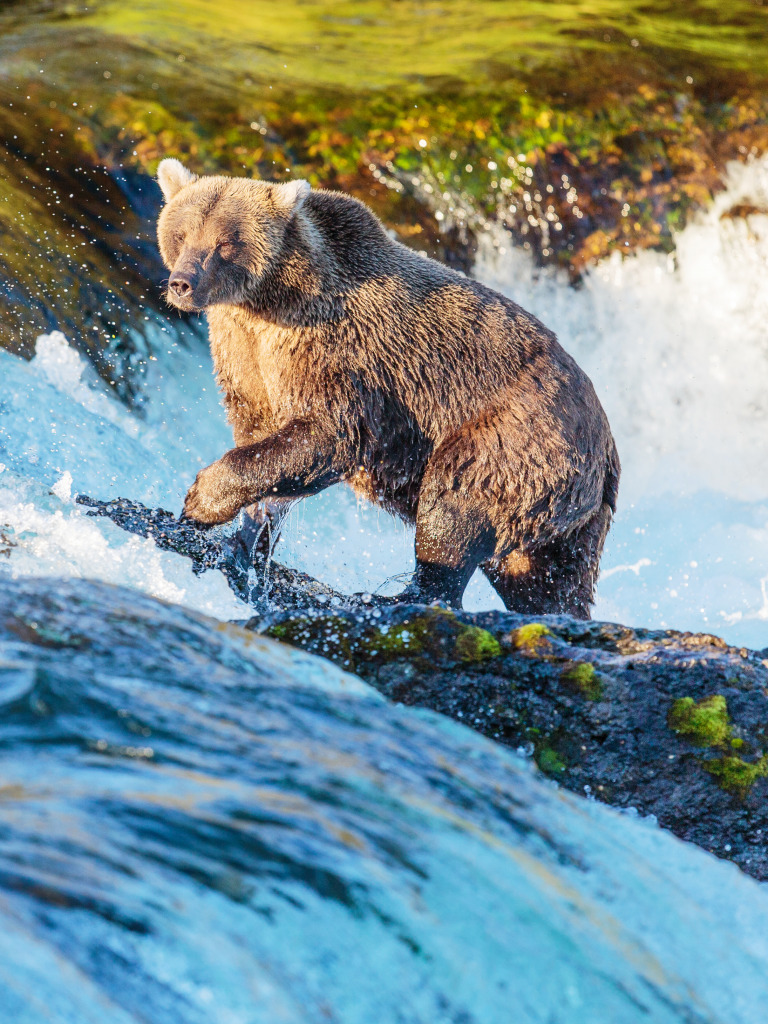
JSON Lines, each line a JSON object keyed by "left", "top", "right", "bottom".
{"left": 0, "top": 0, "right": 768, "bottom": 280}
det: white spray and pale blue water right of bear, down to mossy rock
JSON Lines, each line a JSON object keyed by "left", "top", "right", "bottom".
{"left": 476, "top": 159, "right": 768, "bottom": 647}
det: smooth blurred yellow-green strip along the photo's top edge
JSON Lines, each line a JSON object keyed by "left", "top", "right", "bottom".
{"left": 52, "top": 0, "right": 768, "bottom": 89}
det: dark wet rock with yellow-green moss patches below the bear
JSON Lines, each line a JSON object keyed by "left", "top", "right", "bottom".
{"left": 251, "top": 606, "right": 768, "bottom": 879}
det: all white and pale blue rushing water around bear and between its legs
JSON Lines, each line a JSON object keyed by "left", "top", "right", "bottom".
{"left": 0, "top": 154, "right": 768, "bottom": 647}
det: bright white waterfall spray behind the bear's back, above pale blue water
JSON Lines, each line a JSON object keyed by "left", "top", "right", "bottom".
{"left": 475, "top": 158, "right": 768, "bottom": 504}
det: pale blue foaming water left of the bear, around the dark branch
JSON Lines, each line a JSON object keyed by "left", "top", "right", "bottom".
{"left": 0, "top": 332, "right": 244, "bottom": 618}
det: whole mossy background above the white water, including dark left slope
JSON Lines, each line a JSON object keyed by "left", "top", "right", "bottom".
{"left": 0, "top": 0, "right": 768, "bottom": 387}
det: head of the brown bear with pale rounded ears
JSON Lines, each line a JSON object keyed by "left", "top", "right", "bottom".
{"left": 158, "top": 160, "right": 310, "bottom": 312}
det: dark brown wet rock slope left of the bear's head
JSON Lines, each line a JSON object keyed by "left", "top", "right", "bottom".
{"left": 0, "top": 92, "right": 178, "bottom": 402}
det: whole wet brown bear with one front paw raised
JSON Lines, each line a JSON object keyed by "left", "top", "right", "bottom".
{"left": 158, "top": 160, "right": 620, "bottom": 618}
